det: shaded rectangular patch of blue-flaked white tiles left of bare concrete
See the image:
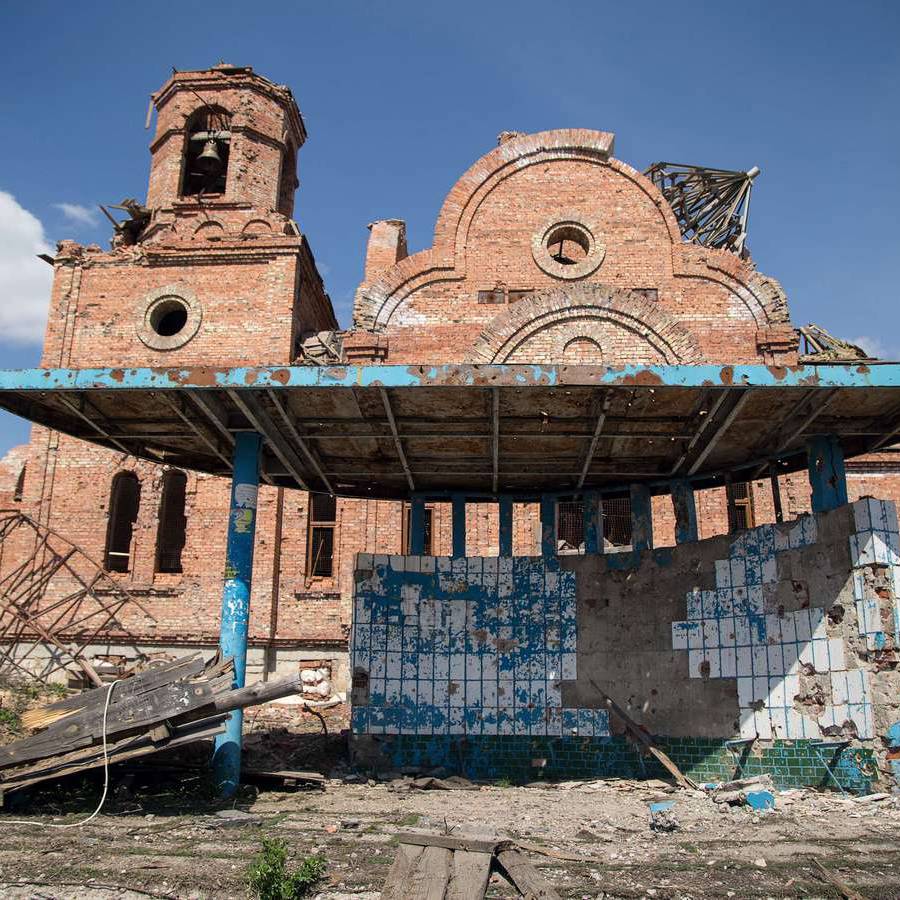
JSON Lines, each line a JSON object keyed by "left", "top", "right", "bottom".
{"left": 351, "top": 553, "right": 609, "bottom": 737}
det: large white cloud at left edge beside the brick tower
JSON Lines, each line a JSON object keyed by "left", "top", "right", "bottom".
{"left": 0, "top": 191, "right": 55, "bottom": 344}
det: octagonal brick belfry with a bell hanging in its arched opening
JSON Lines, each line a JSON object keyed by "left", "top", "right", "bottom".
{"left": 147, "top": 63, "right": 306, "bottom": 223}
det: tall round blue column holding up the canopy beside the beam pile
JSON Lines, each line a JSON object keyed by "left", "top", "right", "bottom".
{"left": 213, "top": 431, "right": 262, "bottom": 797}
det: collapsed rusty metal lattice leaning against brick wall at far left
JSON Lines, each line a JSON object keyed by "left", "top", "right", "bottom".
{"left": 0, "top": 510, "right": 155, "bottom": 685}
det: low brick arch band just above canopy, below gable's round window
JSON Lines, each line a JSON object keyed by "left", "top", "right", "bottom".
{"left": 469, "top": 284, "right": 703, "bottom": 364}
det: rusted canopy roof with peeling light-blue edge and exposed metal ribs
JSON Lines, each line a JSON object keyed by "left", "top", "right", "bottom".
{"left": 0, "top": 364, "right": 900, "bottom": 498}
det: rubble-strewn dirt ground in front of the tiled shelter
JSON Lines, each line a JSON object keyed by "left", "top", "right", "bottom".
{"left": 0, "top": 752, "right": 900, "bottom": 900}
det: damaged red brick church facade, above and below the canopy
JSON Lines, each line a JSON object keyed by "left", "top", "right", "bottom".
{"left": 0, "top": 65, "right": 888, "bottom": 688}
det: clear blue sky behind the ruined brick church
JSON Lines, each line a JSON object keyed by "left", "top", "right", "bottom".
{"left": 0, "top": 0, "right": 900, "bottom": 453}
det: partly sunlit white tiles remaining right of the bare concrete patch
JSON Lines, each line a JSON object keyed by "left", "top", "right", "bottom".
{"left": 672, "top": 498, "right": 900, "bottom": 739}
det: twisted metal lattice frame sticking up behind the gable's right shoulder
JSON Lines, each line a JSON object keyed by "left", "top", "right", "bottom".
{"left": 644, "top": 162, "right": 759, "bottom": 255}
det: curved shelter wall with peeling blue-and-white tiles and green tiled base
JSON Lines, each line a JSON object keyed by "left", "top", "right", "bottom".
{"left": 352, "top": 498, "right": 900, "bottom": 790}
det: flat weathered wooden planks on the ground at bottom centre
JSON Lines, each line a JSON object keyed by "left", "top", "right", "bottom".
{"left": 381, "top": 832, "right": 559, "bottom": 900}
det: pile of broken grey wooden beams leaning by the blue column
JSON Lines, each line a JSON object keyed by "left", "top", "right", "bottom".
{"left": 0, "top": 653, "right": 301, "bottom": 805}
